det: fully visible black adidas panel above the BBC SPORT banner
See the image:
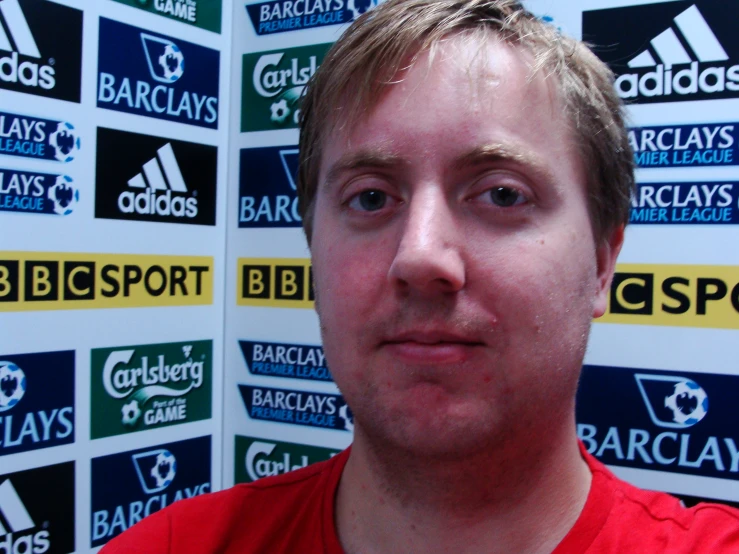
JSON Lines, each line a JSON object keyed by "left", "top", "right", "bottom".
{"left": 95, "top": 128, "right": 217, "bottom": 225}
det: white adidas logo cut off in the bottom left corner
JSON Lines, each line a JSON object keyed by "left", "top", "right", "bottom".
{"left": 0, "top": 479, "right": 51, "bottom": 554}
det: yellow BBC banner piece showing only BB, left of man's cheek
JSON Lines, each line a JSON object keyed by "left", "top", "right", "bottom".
{"left": 236, "top": 258, "right": 314, "bottom": 309}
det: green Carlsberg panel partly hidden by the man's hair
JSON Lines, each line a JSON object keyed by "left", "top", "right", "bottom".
{"left": 241, "top": 43, "right": 331, "bottom": 132}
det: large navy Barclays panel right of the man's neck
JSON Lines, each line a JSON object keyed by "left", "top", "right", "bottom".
{"left": 576, "top": 366, "right": 739, "bottom": 479}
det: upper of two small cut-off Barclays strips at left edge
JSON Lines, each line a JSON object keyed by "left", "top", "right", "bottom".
{"left": 0, "top": 112, "right": 80, "bottom": 163}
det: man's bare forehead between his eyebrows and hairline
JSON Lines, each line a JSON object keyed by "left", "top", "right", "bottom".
{"left": 321, "top": 35, "right": 573, "bottom": 176}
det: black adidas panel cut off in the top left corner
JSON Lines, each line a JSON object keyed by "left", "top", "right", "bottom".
{"left": 0, "top": 0, "right": 82, "bottom": 102}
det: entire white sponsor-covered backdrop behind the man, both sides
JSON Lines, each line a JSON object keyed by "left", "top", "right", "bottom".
{"left": 0, "top": 0, "right": 739, "bottom": 552}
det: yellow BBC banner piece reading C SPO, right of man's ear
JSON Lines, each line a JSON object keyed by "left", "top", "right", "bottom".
{"left": 596, "top": 264, "right": 739, "bottom": 329}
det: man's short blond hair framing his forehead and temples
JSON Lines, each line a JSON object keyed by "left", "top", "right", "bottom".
{"left": 297, "top": 0, "right": 635, "bottom": 243}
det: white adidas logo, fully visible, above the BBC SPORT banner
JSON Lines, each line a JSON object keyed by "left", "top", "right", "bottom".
{"left": 118, "top": 143, "right": 198, "bottom": 218}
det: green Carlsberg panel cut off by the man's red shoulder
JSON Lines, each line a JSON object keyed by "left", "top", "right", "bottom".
{"left": 234, "top": 435, "right": 339, "bottom": 483}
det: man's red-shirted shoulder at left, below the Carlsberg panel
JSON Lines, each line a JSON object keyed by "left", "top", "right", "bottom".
{"left": 103, "top": 453, "right": 345, "bottom": 554}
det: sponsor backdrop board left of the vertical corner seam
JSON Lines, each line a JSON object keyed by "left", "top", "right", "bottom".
{"left": 0, "top": 0, "right": 231, "bottom": 553}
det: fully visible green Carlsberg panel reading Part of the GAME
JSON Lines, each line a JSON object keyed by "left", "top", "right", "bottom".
{"left": 90, "top": 340, "right": 213, "bottom": 439}
